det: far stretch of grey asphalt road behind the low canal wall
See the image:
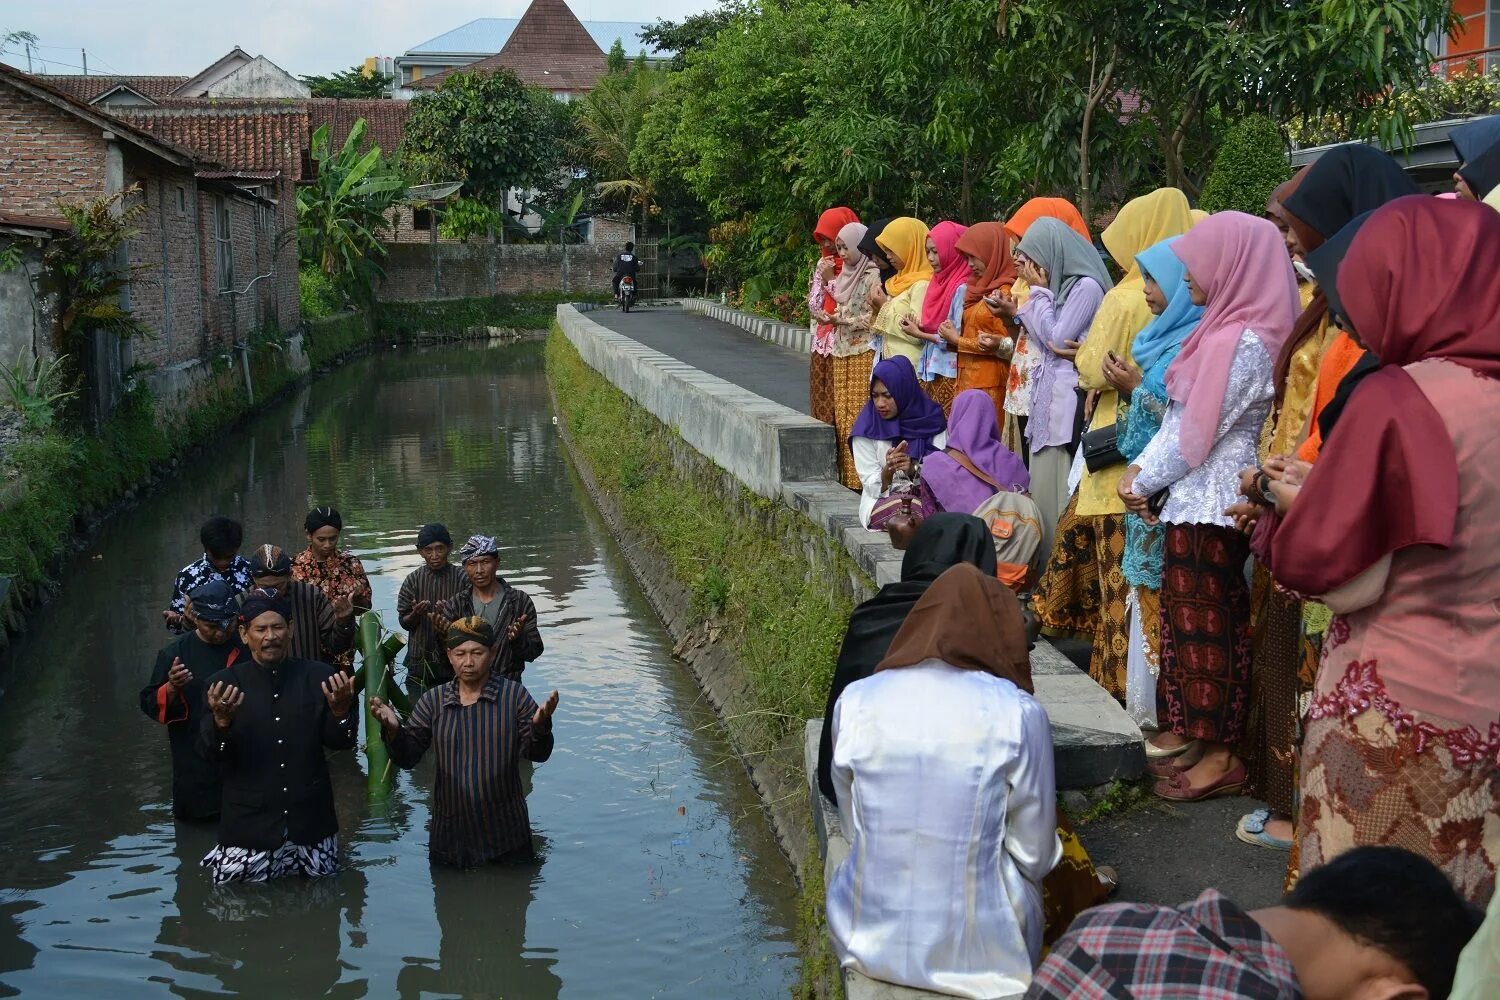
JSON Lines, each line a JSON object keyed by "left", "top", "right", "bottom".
{"left": 588, "top": 306, "right": 809, "bottom": 414}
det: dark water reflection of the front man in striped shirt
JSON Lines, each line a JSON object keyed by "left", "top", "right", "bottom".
{"left": 396, "top": 862, "right": 563, "bottom": 1000}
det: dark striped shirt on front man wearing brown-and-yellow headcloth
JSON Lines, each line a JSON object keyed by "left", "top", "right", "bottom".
{"left": 386, "top": 673, "right": 552, "bottom": 868}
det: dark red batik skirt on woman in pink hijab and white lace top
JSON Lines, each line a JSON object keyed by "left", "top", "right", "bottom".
{"left": 1157, "top": 525, "right": 1253, "bottom": 744}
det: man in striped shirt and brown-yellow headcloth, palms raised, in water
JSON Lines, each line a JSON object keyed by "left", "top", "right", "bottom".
{"left": 371, "top": 616, "right": 558, "bottom": 868}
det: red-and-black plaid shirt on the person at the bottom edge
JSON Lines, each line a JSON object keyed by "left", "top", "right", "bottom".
{"left": 1026, "top": 889, "right": 1302, "bottom": 1000}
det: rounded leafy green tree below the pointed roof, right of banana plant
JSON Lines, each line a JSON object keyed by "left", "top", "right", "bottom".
{"left": 401, "top": 69, "right": 567, "bottom": 207}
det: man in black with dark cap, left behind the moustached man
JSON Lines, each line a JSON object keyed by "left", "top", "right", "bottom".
{"left": 141, "top": 579, "right": 246, "bottom": 822}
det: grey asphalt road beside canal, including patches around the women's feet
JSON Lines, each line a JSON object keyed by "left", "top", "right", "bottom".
{"left": 588, "top": 306, "right": 1287, "bottom": 907}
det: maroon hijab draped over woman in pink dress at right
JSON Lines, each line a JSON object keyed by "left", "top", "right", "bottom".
{"left": 1271, "top": 195, "right": 1500, "bottom": 594}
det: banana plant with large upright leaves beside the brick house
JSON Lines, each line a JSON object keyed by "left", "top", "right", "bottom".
{"left": 297, "top": 118, "right": 407, "bottom": 301}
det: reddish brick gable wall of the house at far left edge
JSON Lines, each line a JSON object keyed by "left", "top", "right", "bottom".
{"left": 0, "top": 84, "right": 105, "bottom": 216}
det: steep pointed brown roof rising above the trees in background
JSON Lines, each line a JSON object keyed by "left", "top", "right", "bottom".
{"left": 413, "top": 0, "right": 608, "bottom": 93}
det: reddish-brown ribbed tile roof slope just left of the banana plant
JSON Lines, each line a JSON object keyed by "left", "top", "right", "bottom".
{"left": 116, "top": 102, "right": 308, "bottom": 180}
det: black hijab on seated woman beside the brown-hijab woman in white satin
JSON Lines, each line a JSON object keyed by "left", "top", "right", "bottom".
{"left": 818, "top": 514, "right": 998, "bottom": 802}
